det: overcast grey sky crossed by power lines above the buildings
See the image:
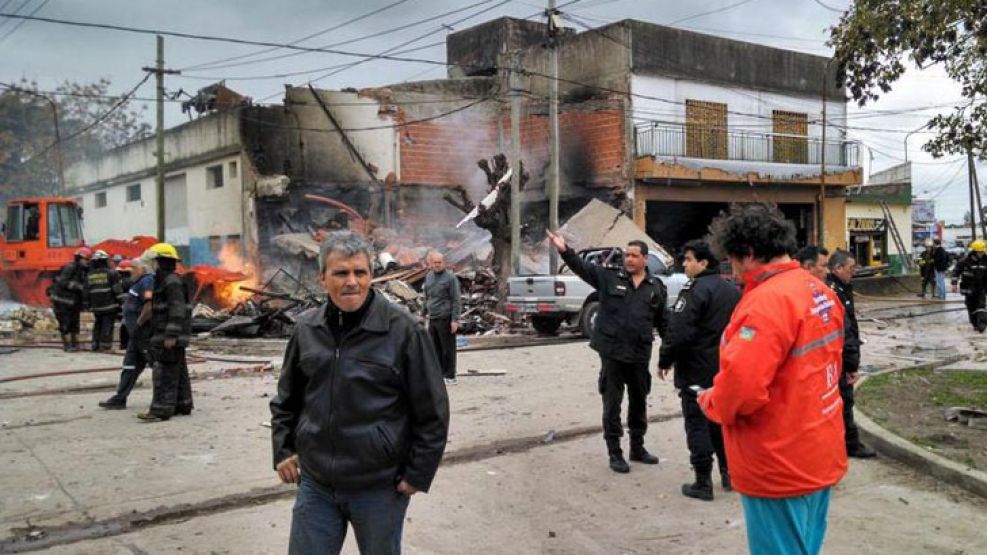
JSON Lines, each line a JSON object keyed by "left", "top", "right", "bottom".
{"left": 0, "top": 0, "right": 987, "bottom": 223}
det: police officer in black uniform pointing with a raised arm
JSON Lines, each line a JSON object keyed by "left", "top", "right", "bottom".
{"left": 548, "top": 232, "right": 668, "bottom": 473}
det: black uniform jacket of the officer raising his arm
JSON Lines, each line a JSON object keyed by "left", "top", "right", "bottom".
{"left": 562, "top": 248, "right": 668, "bottom": 362}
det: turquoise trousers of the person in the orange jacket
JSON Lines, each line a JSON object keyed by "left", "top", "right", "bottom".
{"left": 740, "top": 488, "right": 830, "bottom": 555}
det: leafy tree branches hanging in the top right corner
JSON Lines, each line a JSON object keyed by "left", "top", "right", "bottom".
{"left": 830, "top": 0, "right": 987, "bottom": 158}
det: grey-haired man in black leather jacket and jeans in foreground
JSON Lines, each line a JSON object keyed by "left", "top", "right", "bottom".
{"left": 271, "top": 231, "right": 449, "bottom": 555}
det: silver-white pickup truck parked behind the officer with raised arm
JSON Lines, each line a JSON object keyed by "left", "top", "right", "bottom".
{"left": 507, "top": 247, "right": 689, "bottom": 337}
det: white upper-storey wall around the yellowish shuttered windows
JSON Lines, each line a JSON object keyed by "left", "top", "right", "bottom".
{"left": 631, "top": 75, "right": 846, "bottom": 160}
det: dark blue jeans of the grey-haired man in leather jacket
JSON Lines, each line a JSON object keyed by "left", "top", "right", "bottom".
{"left": 288, "top": 475, "right": 409, "bottom": 555}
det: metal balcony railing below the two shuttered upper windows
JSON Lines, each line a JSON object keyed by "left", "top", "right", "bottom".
{"left": 636, "top": 122, "right": 860, "bottom": 167}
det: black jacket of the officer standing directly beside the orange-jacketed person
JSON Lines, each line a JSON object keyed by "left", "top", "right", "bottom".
{"left": 658, "top": 270, "right": 740, "bottom": 389}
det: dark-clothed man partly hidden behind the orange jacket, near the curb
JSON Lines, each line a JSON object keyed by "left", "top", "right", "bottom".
{"left": 829, "top": 250, "right": 877, "bottom": 459}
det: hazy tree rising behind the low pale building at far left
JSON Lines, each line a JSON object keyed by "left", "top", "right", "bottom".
{"left": 0, "top": 79, "right": 151, "bottom": 203}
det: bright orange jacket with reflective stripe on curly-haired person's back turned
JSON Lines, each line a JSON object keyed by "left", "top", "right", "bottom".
{"left": 699, "top": 262, "right": 847, "bottom": 498}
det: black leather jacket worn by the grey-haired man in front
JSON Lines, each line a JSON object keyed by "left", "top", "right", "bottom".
{"left": 271, "top": 293, "right": 449, "bottom": 491}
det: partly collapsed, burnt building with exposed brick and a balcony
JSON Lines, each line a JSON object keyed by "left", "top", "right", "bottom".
{"left": 66, "top": 18, "right": 861, "bottom": 286}
